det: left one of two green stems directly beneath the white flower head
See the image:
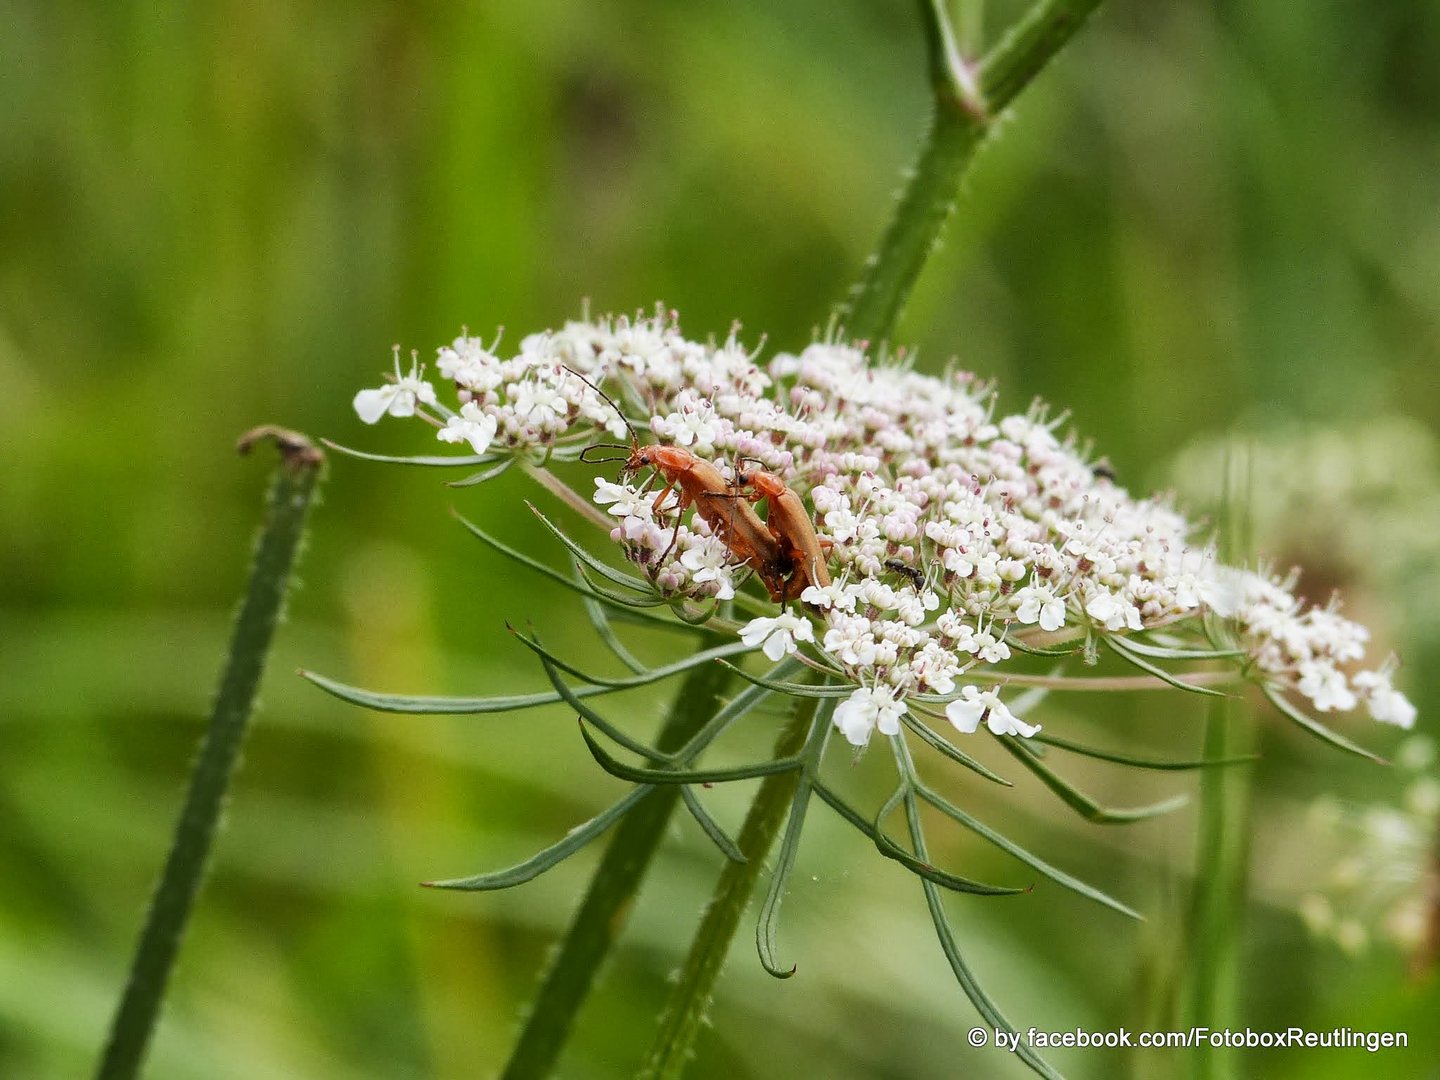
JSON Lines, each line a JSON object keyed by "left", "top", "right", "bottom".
{"left": 501, "top": 650, "right": 730, "bottom": 1080}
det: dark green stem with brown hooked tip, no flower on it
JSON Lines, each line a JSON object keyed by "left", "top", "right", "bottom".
{"left": 96, "top": 428, "right": 325, "bottom": 1080}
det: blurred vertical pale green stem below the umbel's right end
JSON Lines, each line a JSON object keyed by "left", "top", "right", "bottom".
{"left": 1181, "top": 701, "right": 1251, "bottom": 1080}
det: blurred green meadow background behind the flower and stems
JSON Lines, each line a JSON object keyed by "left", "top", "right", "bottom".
{"left": 0, "top": 0, "right": 1440, "bottom": 1079}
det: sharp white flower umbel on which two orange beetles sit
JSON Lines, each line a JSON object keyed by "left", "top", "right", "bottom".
{"left": 356, "top": 315, "right": 1414, "bottom": 746}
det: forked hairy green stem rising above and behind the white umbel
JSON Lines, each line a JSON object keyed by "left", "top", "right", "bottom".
{"left": 842, "top": 0, "right": 1100, "bottom": 341}
